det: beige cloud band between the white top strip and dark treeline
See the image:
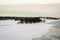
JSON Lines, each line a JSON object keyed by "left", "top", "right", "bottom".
{"left": 0, "top": 4, "right": 60, "bottom": 17}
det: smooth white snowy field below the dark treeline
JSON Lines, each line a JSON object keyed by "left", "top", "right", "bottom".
{"left": 0, "top": 20, "right": 58, "bottom": 40}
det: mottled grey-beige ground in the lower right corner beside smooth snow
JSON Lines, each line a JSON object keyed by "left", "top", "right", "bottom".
{"left": 33, "top": 20, "right": 60, "bottom": 40}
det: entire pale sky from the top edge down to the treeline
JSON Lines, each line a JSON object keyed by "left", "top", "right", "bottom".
{"left": 0, "top": 0, "right": 60, "bottom": 17}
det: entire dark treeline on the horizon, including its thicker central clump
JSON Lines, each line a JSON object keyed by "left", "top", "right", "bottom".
{"left": 0, "top": 17, "right": 59, "bottom": 24}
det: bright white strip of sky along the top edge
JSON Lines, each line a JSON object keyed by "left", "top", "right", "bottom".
{"left": 0, "top": 0, "right": 60, "bottom": 4}
